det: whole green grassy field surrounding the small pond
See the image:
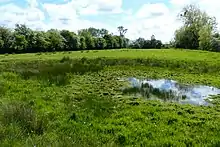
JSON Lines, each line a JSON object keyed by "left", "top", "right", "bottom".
{"left": 0, "top": 50, "right": 220, "bottom": 147}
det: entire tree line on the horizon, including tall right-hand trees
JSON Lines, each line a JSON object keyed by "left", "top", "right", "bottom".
{"left": 0, "top": 5, "right": 220, "bottom": 54}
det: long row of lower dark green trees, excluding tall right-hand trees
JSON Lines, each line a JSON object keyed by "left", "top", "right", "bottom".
{"left": 0, "top": 24, "right": 162, "bottom": 54}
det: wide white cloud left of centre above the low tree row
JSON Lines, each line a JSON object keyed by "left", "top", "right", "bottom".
{"left": 43, "top": 0, "right": 117, "bottom": 31}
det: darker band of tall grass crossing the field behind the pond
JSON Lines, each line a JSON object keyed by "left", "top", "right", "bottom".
{"left": 0, "top": 57, "right": 220, "bottom": 77}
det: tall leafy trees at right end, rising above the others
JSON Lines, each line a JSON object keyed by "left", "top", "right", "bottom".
{"left": 175, "top": 4, "right": 218, "bottom": 51}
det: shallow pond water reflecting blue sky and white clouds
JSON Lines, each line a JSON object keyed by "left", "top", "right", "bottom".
{"left": 121, "top": 78, "right": 220, "bottom": 105}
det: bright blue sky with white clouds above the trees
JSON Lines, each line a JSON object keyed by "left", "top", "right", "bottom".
{"left": 0, "top": 0, "right": 220, "bottom": 42}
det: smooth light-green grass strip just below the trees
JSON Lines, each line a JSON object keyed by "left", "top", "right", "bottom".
{"left": 0, "top": 49, "right": 220, "bottom": 62}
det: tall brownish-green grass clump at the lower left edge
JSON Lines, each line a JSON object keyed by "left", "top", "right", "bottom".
{"left": 0, "top": 102, "right": 46, "bottom": 135}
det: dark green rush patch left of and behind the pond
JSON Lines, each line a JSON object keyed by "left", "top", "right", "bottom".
{"left": 8, "top": 56, "right": 104, "bottom": 86}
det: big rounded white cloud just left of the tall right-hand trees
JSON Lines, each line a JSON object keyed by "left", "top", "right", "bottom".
{"left": 125, "top": 3, "right": 179, "bottom": 42}
